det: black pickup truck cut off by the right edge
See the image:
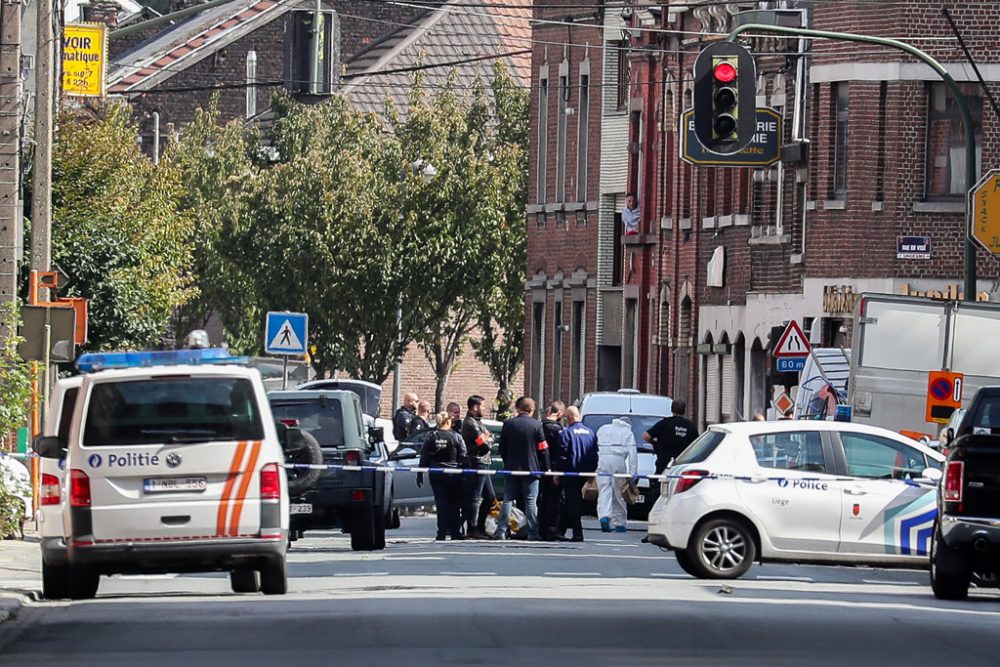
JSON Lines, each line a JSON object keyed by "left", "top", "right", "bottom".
{"left": 930, "top": 387, "right": 1000, "bottom": 600}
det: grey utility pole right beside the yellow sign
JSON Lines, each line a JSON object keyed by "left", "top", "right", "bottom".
{"left": 31, "top": 0, "right": 55, "bottom": 301}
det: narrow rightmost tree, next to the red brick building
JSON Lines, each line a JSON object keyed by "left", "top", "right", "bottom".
{"left": 472, "top": 63, "right": 530, "bottom": 392}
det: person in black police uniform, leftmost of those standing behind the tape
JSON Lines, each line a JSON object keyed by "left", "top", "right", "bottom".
{"left": 417, "top": 412, "right": 468, "bottom": 540}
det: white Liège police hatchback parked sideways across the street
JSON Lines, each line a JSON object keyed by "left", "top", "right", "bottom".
{"left": 648, "top": 421, "right": 944, "bottom": 579}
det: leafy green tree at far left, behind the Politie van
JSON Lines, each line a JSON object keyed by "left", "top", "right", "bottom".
{"left": 52, "top": 104, "right": 195, "bottom": 350}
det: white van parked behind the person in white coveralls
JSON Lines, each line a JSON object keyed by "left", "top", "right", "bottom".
{"left": 579, "top": 389, "right": 673, "bottom": 515}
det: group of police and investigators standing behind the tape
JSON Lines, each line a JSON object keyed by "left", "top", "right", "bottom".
{"left": 393, "top": 394, "right": 697, "bottom": 542}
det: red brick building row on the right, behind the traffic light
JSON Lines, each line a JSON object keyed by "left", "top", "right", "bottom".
{"left": 526, "top": 0, "right": 1000, "bottom": 424}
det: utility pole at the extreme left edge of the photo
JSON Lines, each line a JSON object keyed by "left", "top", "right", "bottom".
{"left": 0, "top": 0, "right": 22, "bottom": 310}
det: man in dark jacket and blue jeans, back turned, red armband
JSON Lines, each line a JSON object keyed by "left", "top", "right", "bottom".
{"left": 493, "top": 396, "right": 550, "bottom": 541}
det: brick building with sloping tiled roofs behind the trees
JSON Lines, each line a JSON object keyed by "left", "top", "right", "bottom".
{"left": 104, "top": 0, "right": 531, "bottom": 413}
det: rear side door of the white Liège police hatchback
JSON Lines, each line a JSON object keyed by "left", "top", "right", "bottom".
{"left": 736, "top": 429, "right": 841, "bottom": 554}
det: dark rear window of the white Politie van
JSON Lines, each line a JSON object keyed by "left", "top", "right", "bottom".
{"left": 83, "top": 376, "right": 264, "bottom": 447}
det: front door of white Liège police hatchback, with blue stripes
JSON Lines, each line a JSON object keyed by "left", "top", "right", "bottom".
{"left": 838, "top": 431, "right": 937, "bottom": 557}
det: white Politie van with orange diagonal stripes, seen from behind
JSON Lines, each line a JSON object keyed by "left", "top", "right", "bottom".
{"left": 36, "top": 351, "right": 289, "bottom": 599}
